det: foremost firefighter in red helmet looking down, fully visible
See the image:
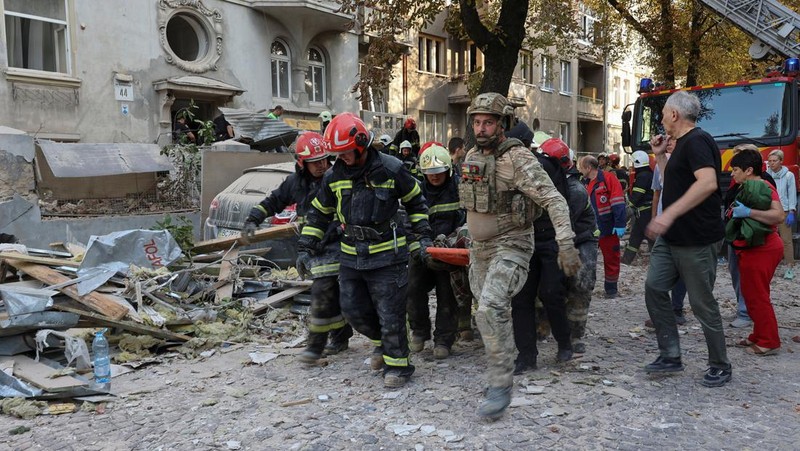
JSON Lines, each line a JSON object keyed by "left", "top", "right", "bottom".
{"left": 297, "top": 113, "right": 433, "bottom": 387}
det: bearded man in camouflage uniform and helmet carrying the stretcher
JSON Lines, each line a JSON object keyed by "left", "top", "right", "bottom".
{"left": 458, "top": 93, "right": 580, "bottom": 419}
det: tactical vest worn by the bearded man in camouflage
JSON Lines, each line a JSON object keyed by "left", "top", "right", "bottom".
{"left": 458, "top": 138, "right": 533, "bottom": 228}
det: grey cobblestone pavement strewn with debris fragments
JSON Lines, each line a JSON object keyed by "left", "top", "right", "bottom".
{"left": 0, "top": 260, "right": 800, "bottom": 450}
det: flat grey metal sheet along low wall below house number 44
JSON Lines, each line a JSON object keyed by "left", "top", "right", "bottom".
{"left": 38, "top": 141, "right": 174, "bottom": 177}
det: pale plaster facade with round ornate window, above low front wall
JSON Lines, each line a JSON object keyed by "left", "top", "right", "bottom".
{"left": 0, "top": 0, "right": 358, "bottom": 144}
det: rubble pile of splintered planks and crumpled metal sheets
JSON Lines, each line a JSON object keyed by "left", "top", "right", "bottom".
{"left": 0, "top": 224, "right": 311, "bottom": 417}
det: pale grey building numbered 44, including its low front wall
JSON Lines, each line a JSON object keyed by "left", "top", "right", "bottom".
{"left": 0, "top": 0, "right": 358, "bottom": 246}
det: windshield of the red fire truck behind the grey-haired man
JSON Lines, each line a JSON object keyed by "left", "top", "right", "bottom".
{"left": 636, "top": 82, "right": 791, "bottom": 145}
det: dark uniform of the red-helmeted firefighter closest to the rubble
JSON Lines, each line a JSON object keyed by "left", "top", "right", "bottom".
{"left": 247, "top": 162, "right": 353, "bottom": 354}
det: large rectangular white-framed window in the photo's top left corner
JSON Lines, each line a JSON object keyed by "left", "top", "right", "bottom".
{"left": 4, "top": 0, "right": 70, "bottom": 74}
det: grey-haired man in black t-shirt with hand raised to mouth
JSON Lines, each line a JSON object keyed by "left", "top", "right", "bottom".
{"left": 645, "top": 91, "right": 732, "bottom": 387}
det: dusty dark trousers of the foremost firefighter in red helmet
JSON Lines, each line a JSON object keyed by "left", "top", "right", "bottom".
{"left": 339, "top": 263, "right": 414, "bottom": 376}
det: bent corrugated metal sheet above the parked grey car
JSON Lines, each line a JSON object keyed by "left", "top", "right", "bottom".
{"left": 219, "top": 108, "right": 299, "bottom": 149}
